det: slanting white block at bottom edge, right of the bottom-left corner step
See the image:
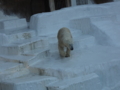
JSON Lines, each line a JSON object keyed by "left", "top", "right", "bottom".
{"left": 47, "top": 73, "right": 102, "bottom": 90}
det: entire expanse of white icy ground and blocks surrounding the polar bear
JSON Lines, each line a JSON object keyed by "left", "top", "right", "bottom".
{"left": 0, "top": 2, "right": 120, "bottom": 90}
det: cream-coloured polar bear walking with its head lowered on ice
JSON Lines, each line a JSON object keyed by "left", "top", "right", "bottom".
{"left": 57, "top": 27, "right": 73, "bottom": 57}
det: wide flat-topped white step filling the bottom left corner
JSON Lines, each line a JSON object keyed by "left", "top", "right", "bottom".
{"left": 0, "top": 75, "right": 57, "bottom": 90}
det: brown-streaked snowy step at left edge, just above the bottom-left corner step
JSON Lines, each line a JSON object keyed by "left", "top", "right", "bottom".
{"left": 0, "top": 60, "right": 28, "bottom": 81}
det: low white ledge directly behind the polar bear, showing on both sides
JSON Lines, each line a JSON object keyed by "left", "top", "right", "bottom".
{"left": 49, "top": 35, "right": 97, "bottom": 53}
